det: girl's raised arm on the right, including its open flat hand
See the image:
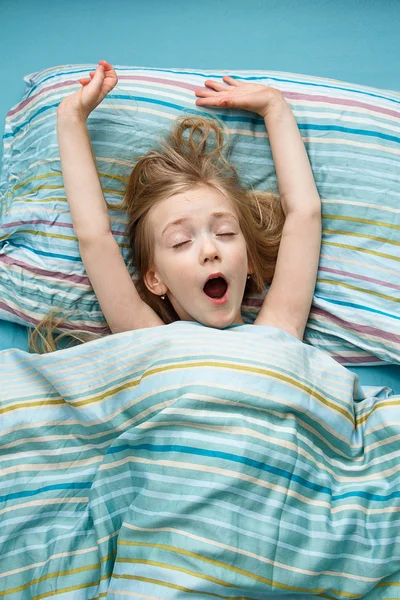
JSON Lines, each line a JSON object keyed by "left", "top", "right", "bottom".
{"left": 195, "top": 77, "right": 321, "bottom": 340}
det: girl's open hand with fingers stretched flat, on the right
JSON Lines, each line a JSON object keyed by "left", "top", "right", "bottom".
{"left": 194, "top": 75, "right": 284, "bottom": 117}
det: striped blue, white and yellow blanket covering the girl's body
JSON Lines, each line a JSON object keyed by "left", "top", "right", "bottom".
{"left": 0, "top": 322, "right": 400, "bottom": 600}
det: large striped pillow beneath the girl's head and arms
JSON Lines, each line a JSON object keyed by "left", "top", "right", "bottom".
{"left": 0, "top": 64, "right": 400, "bottom": 365}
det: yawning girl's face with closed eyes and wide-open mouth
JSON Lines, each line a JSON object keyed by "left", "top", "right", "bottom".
{"left": 145, "top": 186, "right": 252, "bottom": 329}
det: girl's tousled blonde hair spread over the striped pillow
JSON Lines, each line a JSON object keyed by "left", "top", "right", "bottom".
{"left": 29, "top": 116, "right": 285, "bottom": 353}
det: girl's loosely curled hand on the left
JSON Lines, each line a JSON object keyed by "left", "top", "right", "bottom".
{"left": 59, "top": 60, "right": 118, "bottom": 120}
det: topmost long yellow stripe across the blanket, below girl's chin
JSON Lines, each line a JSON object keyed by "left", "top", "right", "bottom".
{"left": 0, "top": 361, "right": 354, "bottom": 423}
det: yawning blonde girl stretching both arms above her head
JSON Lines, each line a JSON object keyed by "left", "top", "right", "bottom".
{"left": 30, "top": 60, "right": 321, "bottom": 351}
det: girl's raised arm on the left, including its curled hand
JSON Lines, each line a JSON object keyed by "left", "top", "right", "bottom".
{"left": 57, "top": 61, "right": 164, "bottom": 333}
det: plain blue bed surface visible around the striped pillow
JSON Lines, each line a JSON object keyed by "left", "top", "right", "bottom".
{"left": 0, "top": 0, "right": 400, "bottom": 393}
